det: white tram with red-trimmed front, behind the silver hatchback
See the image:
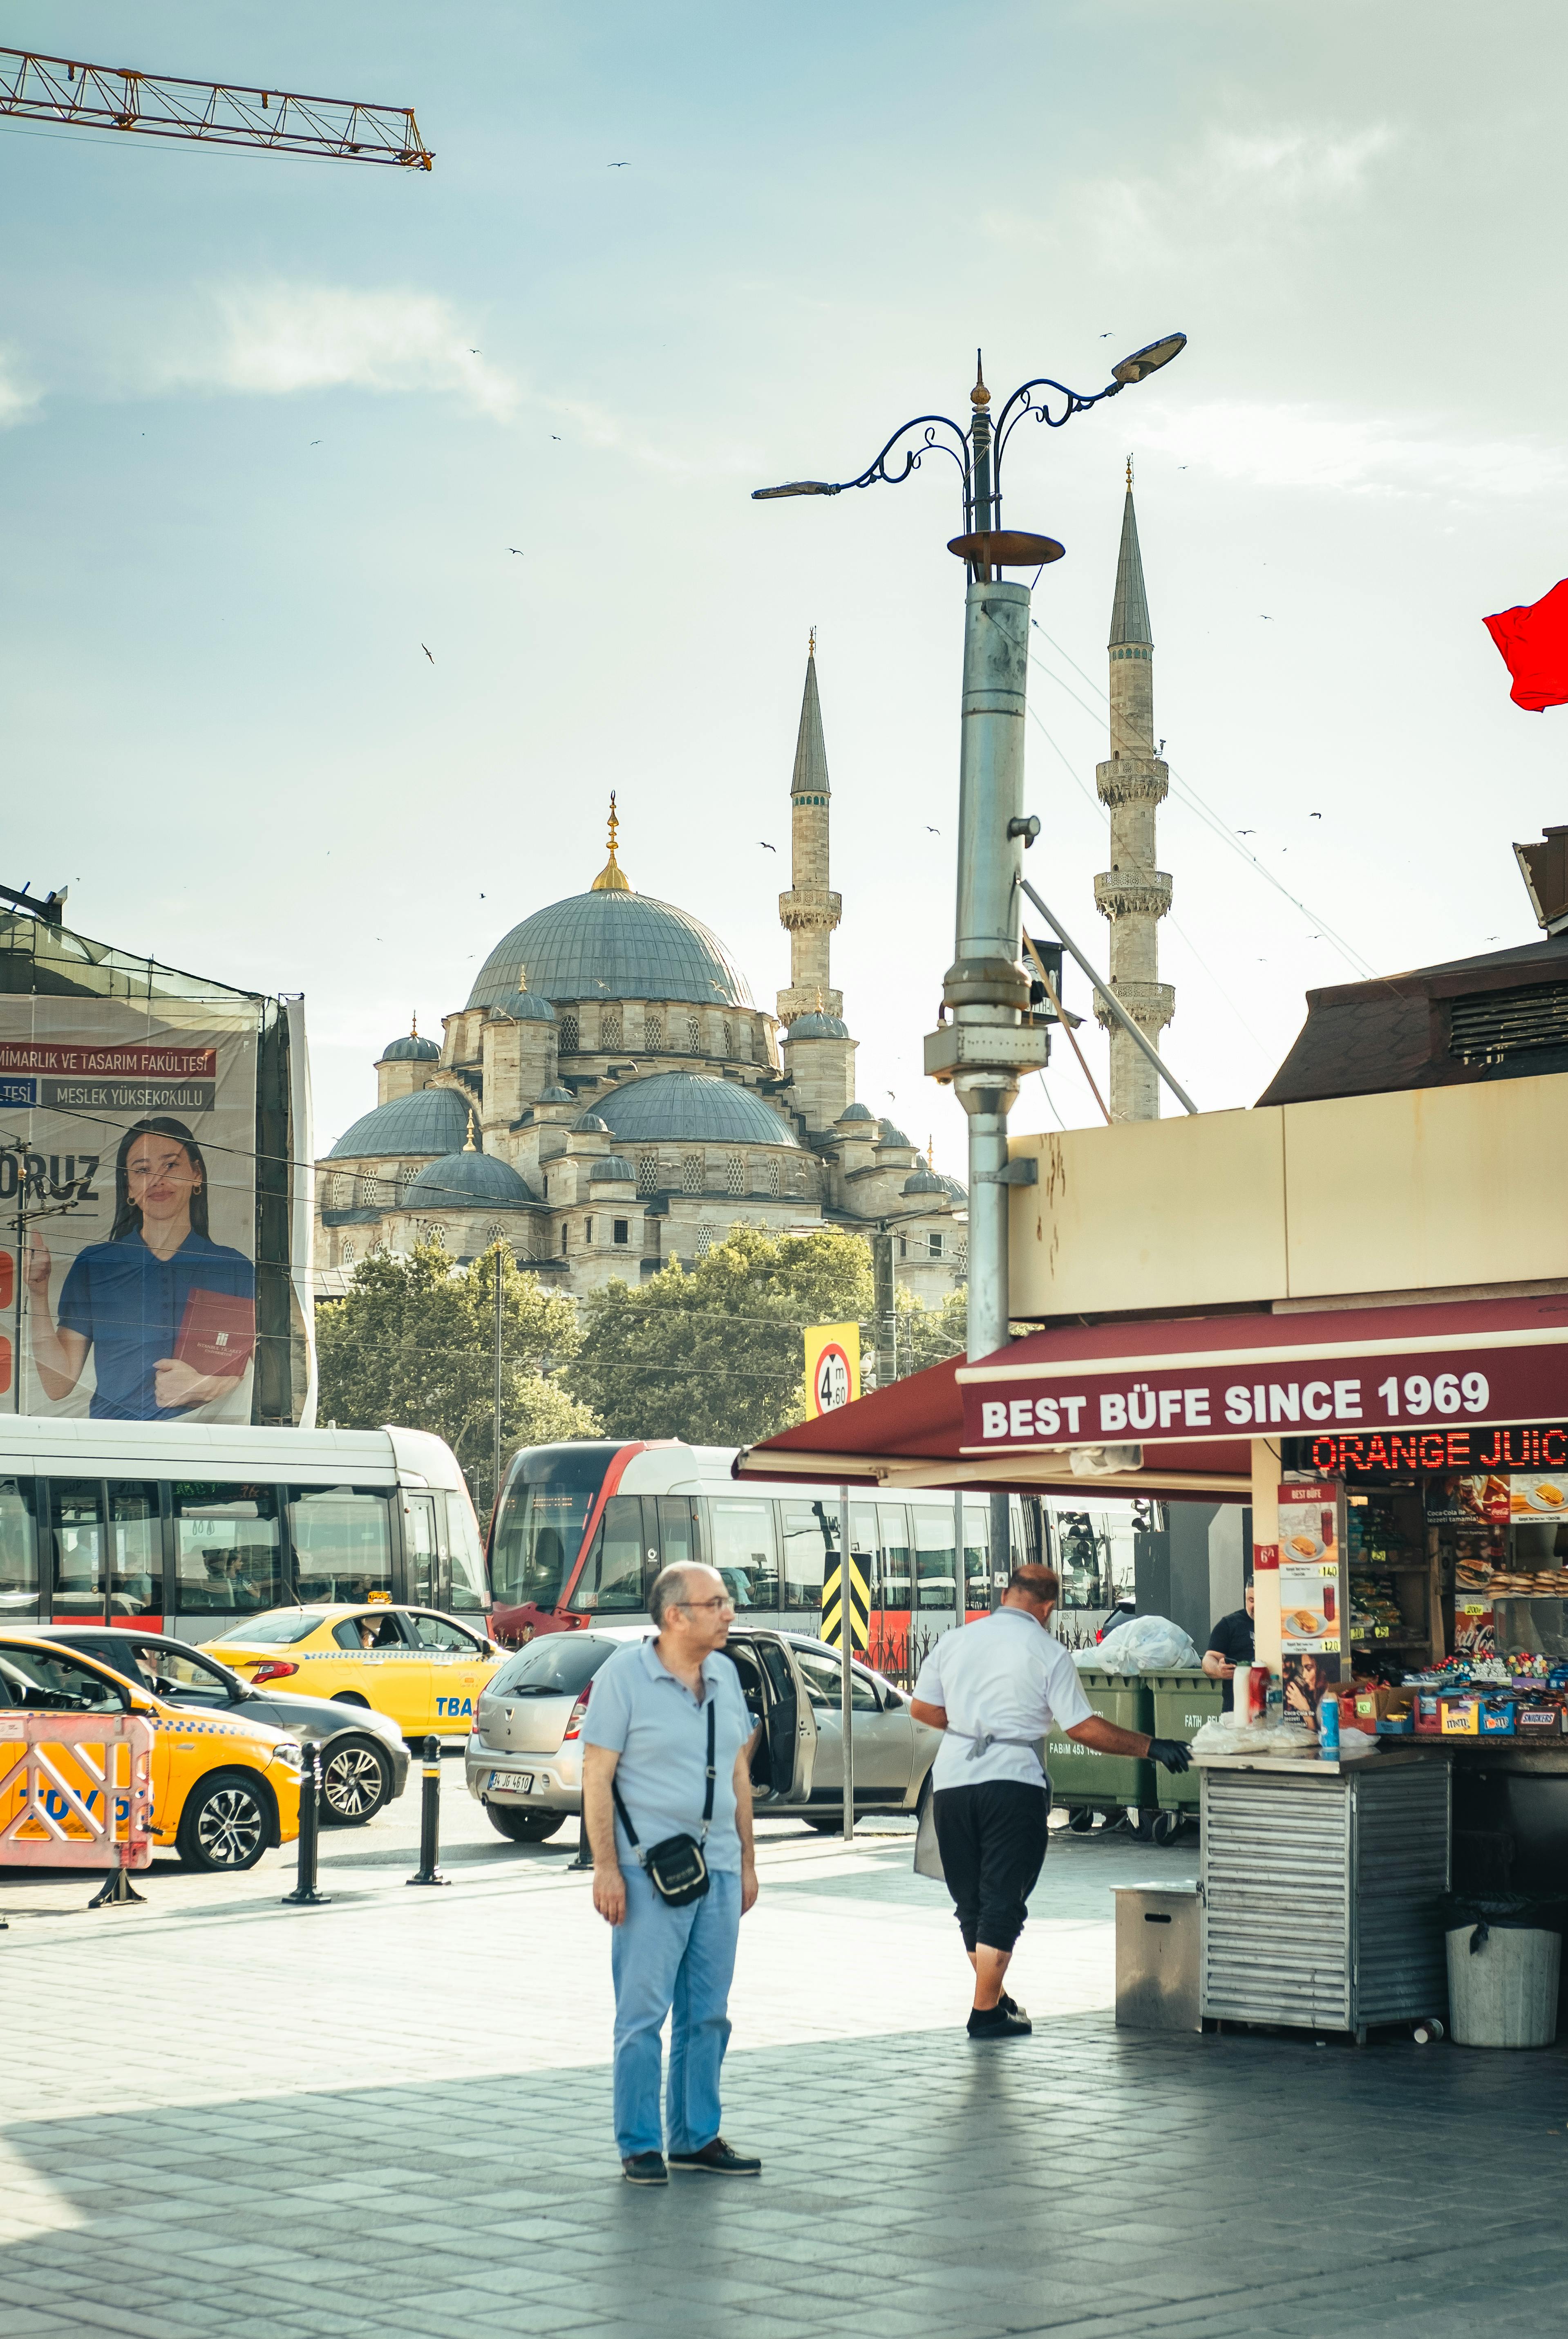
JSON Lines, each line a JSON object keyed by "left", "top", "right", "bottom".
{"left": 489, "top": 1439, "right": 1133, "bottom": 1672}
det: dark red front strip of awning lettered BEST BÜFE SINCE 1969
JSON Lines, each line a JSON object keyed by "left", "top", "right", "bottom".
{"left": 964, "top": 1340, "right": 1568, "bottom": 1453}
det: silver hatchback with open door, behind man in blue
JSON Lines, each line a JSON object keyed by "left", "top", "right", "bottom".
{"left": 468, "top": 1623, "right": 941, "bottom": 1843}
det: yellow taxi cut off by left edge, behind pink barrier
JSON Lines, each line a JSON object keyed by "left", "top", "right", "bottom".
{"left": 0, "top": 1630, "right": 300, "bottom": 1873}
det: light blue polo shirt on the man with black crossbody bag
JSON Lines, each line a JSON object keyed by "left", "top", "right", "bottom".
{"left": 583, "top": 1640, "right": 756, "bottom": 1873}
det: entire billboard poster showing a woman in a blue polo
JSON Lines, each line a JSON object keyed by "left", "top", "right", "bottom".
{"left": 0, "top": 994, "right": 257, "bottom": 1422}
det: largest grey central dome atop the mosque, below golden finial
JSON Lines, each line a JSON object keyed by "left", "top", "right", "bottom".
{"left": 468, "top": 889, "right": 754, "bottom": 1013}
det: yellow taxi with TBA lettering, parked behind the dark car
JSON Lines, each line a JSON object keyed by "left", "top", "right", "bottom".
{"left": 206, "top": 1600, "right": 508, "bottom": 1738}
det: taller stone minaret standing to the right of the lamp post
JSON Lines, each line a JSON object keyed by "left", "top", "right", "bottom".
{"left": 1095, "top": 456, "right": 1175, "bottom": 1120}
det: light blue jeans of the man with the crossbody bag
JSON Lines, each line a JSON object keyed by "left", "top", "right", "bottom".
{"left": 611, "top": 1860, "right": 740, "bottom": 2159}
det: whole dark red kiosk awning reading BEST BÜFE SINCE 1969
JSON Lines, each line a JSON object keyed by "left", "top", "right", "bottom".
{"left": 735, "top": 1296, "right": 1568, "bottom": 1499}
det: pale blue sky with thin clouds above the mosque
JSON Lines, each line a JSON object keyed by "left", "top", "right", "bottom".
{"left": 0, "top": 0, "right": 1568, "bottom": 1170}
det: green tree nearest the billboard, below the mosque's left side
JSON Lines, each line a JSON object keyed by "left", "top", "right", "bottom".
{"left": 316, "top": 1242, "right": 599, "bottom": 1518}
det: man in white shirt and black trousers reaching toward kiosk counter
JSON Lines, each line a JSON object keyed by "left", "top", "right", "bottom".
{"left": 910, "top": 1565, "right": 1191, "bottom": 2039}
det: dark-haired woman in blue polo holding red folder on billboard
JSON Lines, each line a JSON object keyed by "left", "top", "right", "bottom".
{"left": 28, "top": 1118, "right": 255, "bottom": 1422}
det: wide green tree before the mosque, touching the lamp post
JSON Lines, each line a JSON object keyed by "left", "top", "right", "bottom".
{"left": 566, "top": 1223, "right": 966, "bottom": 1446}
